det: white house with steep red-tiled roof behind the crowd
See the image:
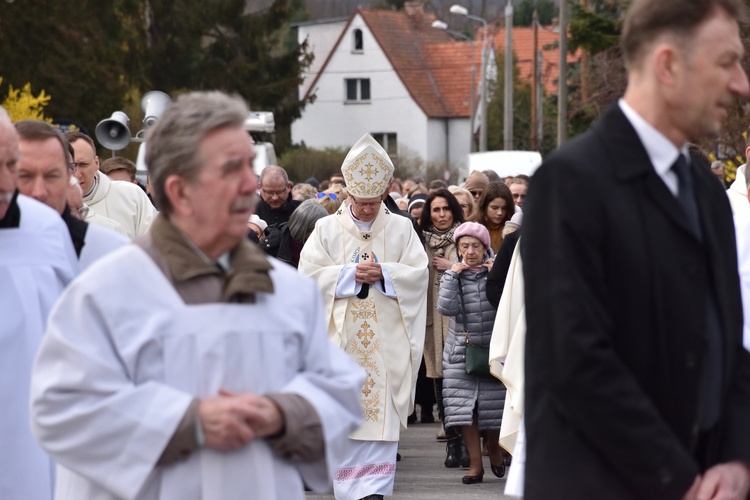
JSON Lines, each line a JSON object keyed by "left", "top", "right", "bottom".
{"left": 292, "top": 3, "right": 480, "bottom": 172}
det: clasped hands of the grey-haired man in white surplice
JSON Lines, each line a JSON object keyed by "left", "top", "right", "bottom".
{"left": 198, "top": 389, "right": 284, "bottom": 451}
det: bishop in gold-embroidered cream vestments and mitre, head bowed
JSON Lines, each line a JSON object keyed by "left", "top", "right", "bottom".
{"left": 299, "top": 134, "right": 428, "bottom": 500}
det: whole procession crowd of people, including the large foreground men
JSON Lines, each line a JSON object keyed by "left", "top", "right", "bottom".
{"left": 7, "top": 0, "right": 750, "bottom": 500}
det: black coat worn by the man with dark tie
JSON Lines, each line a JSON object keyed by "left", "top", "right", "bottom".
{"left": 521, "top": 105, "right": 750, "bottom": 500}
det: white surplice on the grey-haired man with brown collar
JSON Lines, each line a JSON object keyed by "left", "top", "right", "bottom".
{"left": 32, "top": 245, "right": 364, "bottom": 500}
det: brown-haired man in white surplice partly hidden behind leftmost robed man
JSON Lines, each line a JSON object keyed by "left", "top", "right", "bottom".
{"left": 16, "top": 120, "right": 128, "bottom": 269}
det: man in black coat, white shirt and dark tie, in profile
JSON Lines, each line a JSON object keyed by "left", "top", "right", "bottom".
{"left": 521, "top": 0, "right": 750, "bottom": 500}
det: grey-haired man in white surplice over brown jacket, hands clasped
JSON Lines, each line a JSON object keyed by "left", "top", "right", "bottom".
{"left": 31, "top": 92, "right": 364, "bottom": 500}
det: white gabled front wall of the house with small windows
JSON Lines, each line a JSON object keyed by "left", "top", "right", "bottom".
{"left": 292, "top": 15, "right": 428, "bottom": 159}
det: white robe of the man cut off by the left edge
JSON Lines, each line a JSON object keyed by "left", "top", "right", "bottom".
{"left": 0, "top": 195, "right": 78, "bottom": 500}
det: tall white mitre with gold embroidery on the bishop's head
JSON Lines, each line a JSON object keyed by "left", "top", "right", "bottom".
{"left": 341, "top": 134, "right": 394, "bottom": 198}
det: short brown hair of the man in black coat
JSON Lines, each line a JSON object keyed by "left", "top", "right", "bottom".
{"left": 620, "top": 0, "right": 746, "bottom": 67}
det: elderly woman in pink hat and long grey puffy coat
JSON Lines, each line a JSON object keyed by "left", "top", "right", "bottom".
{"left": 437, "top": 222, "right": 505, "bottom": 484}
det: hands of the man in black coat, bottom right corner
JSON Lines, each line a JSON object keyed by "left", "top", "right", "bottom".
{"left": 683, "top": 462, "right": 750, "bottom": 500}
